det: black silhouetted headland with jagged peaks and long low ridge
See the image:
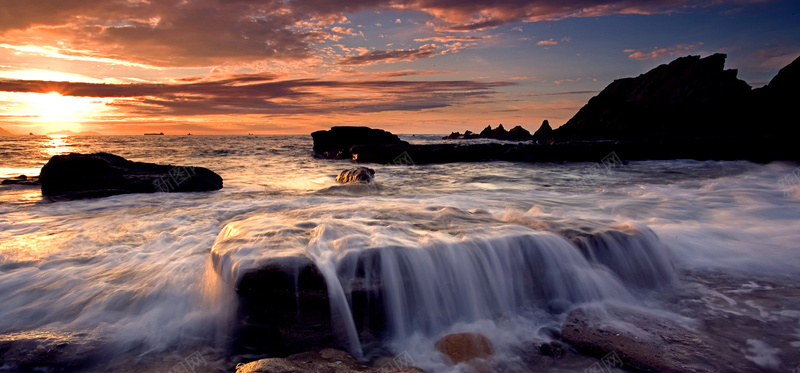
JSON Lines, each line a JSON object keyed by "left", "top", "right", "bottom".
{"left": 314, "top": 54, "right": 800, "bottom": 164}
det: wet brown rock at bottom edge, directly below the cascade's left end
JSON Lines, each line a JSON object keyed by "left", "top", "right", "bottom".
{"left": 236, "top": 349, "right": 425, "bottom": 373}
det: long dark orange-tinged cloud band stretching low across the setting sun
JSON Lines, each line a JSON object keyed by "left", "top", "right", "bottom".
{"left": 0, "top": 75, "right": 513, "bottom": 116}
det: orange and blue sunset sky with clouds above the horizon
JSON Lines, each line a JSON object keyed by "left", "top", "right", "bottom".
{"left": 0, "top": 0, "right": 800, "bottom": 134}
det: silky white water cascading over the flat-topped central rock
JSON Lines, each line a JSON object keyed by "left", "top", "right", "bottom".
{"left": 213, "top": 202, "right": 676, "bottom": 357}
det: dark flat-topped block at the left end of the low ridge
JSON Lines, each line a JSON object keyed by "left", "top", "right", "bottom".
{"left": 311, "top": 126, "right": 408, "bottom": 159}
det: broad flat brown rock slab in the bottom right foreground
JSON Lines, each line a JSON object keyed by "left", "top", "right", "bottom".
{"left": 562, "top": 309, "right": 762, "bottom": 373}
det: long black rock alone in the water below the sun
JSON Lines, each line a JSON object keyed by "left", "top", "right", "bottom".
{"left": 39, "top": 153, "right": 222, "bottom": 200}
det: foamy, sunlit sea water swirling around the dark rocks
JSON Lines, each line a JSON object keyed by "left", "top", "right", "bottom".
{"left": 0, "top": 135, "right": 800, "bottom": 372}
